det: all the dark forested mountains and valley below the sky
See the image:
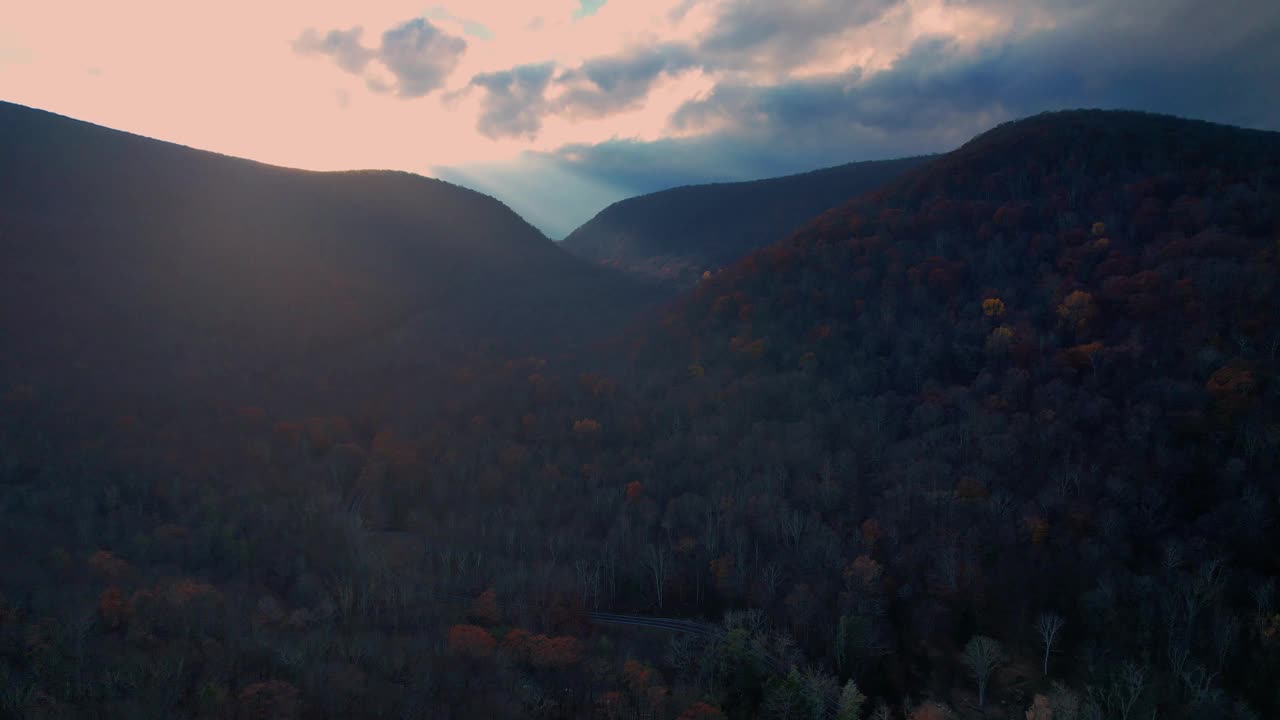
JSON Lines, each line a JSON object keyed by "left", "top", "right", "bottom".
{"left": 0, "top": 104, "right": 1280, "bottom": 720}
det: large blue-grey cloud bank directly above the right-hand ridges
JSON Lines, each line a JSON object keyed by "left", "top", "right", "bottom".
{"left": 552, "top": 0, "right": 1280, "bottom": 192}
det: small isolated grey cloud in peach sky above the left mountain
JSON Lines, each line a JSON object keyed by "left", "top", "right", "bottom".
{"left": 293, "top": 18, "right": 467, "bottom": 97}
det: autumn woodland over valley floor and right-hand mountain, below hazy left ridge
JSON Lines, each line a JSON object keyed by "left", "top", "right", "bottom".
{"left": 0, "top": 111, "right": 1280, "bottom": 720}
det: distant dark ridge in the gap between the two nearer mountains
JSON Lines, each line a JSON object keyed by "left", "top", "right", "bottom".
{"left": 562, "top": 156, "right": 929, "bottom": 284}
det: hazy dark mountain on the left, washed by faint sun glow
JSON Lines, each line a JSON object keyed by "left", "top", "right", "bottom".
{"left": 0, "top": 104, "right": 652, "bottom": 415}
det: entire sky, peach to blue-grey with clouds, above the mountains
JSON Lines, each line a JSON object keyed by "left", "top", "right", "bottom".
{"left": 0, "top": 0, "right": 1280, "bottom": 240}
